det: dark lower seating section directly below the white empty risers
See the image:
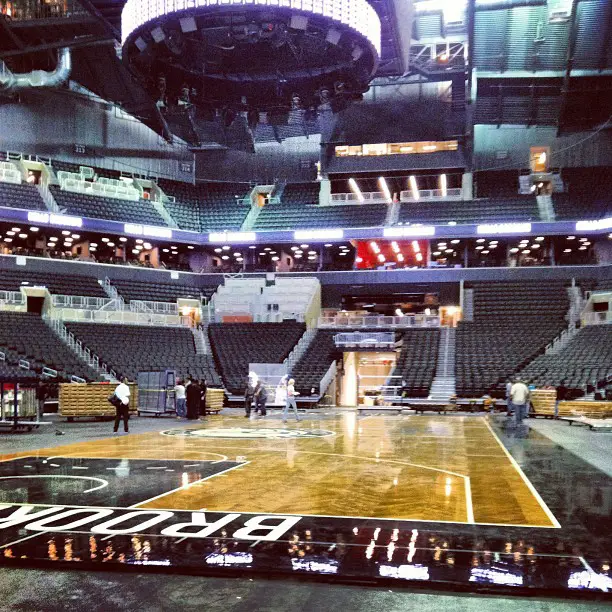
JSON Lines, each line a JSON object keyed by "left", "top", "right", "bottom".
{"left": 208, "top": 321, "right": 306, "bottom": 395}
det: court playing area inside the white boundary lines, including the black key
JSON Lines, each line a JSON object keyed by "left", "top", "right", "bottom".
{"left": 0, "top": 413, "right": 559, "bottom": 528}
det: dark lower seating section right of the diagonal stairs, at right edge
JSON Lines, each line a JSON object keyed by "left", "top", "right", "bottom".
{"left": 521, "top": 325, "right": 612, "bottom": 390}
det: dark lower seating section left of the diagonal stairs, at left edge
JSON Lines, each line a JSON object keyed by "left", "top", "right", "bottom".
{"left": 0, "top": 311, "right": 98, "bottom": 380}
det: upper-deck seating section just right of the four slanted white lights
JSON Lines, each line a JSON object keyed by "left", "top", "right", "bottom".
{"left": 398, "top": 196, "right": 540, "bottom": 224}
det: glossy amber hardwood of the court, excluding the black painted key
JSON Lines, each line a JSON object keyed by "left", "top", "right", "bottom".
{"left": 2, "top": 412, "right": 559, "bottom": 527}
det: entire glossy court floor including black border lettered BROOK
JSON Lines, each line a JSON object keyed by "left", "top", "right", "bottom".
{"left": 0, "top": 413, "right": 612, "bottom": 592}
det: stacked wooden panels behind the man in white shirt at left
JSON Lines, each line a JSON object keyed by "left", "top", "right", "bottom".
{"left": 59, "top": 383, "right": 138, "bottom": 421}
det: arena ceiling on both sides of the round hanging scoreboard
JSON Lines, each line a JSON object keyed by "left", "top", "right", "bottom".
{"left": 0, "top": 0, "right": 612, "bottom": 141}
